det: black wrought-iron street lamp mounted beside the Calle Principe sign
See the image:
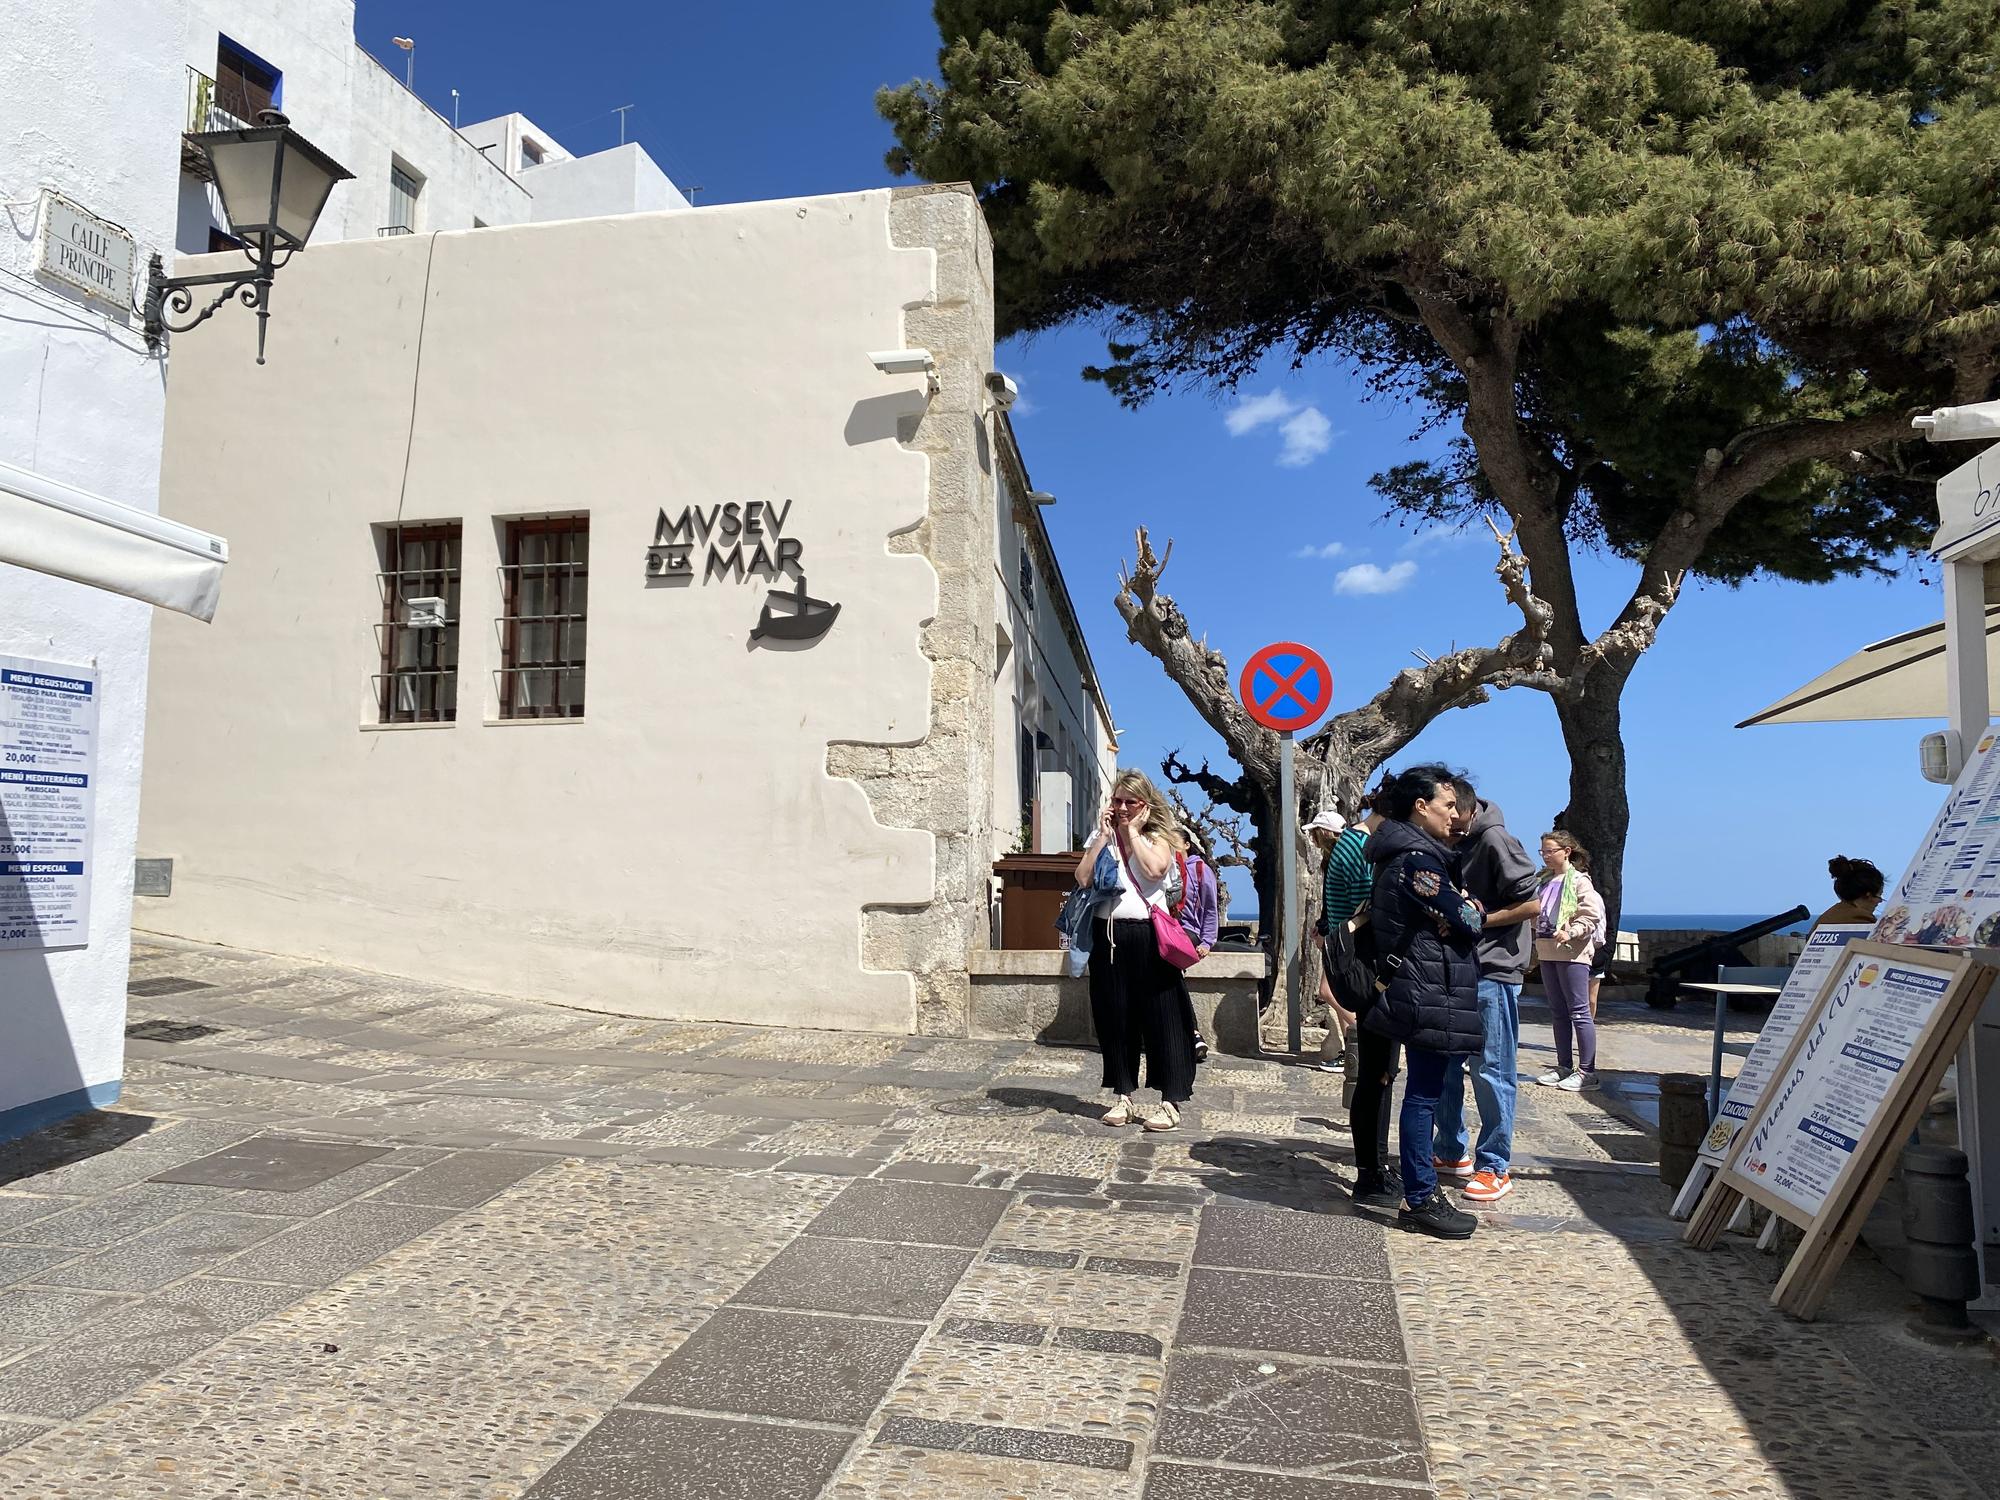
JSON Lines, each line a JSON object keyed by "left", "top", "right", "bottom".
{"left": 146, "top": 110, "right": 354, "bottom": 364}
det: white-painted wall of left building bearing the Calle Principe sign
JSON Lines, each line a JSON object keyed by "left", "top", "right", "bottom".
{"left": 0, "top": 0, "right": 184, "bottom": 1136}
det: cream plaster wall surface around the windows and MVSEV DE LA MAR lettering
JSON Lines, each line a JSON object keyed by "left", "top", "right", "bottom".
{"left": 140, "top": 192, "right": 952, "bottom": 1032}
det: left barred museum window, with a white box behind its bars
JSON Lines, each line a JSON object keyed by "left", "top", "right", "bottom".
{"left": 376, "top": 520, "right": 464, "bottom": 724}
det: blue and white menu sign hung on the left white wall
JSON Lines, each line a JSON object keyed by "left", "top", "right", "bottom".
{"left": 0, "top": 656, "right": 98, "bottom": 950}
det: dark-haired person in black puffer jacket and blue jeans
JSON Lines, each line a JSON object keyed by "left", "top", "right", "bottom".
{"left": 1362, "top": 766, "right": 1486, "bottom": 1240}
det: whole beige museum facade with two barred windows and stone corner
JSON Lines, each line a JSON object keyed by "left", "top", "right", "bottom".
{"left": 136, "top": 188, "right": 1110, "bottom": 1034}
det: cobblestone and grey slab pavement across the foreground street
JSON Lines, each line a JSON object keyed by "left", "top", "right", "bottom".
{"left": 0, "top": 944, "right": 2000, "bottom": 1500}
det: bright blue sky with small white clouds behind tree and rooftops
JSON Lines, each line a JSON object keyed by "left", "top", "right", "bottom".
{"left": 356, "top": 0, "right": 1942, "bottom": 912}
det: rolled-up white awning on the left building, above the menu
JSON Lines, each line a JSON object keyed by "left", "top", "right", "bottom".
{"left": 0, "top": 464, "right": 230, "bottom": 620}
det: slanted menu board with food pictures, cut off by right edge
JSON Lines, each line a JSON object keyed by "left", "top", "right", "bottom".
{"left": 1874, "top": 730, "right": 2000, "bottom": 950}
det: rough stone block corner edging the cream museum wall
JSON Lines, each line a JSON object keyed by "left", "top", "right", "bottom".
{"left": 826, "top": 184, "right": 994, "bottom": 1036}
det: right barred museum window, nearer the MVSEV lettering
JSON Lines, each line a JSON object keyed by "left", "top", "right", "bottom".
{"left": 500, "top": 516, "right": 590, "bottom": 718}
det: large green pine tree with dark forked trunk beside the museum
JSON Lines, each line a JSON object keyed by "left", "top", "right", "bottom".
{"left": 878, "top": 0, "right": 2000, "bottom": 928}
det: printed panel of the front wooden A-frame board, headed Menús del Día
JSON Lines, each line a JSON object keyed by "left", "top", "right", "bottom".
{"left": 1730, "top": 944, "right": 1964, "bottom": 1220}
